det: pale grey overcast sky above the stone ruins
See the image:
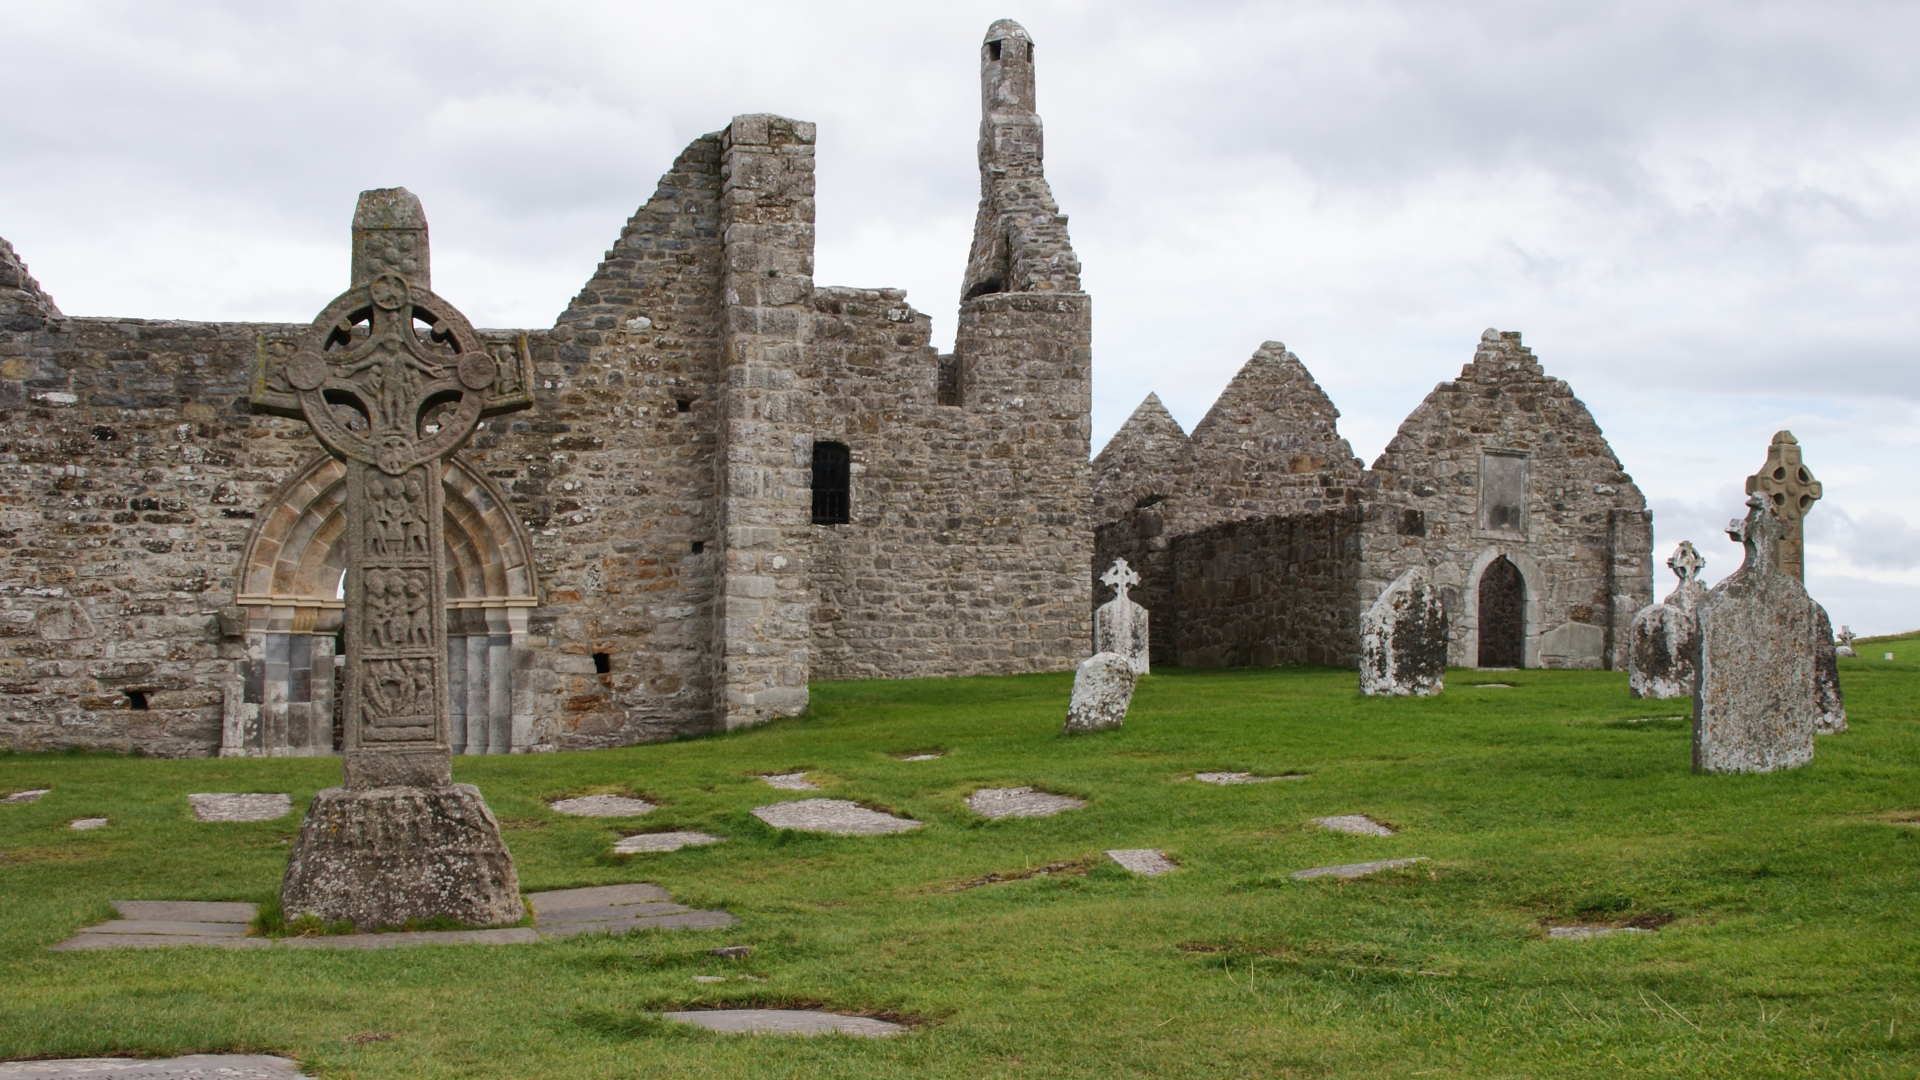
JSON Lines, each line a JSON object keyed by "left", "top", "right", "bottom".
{"left": 11, "top": 0, "right": 1920, "bottom": 634}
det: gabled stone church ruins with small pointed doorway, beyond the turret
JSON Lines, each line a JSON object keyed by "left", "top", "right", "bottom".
{"left": 1092, "top": 331, "right": 1653, "bottom": 671}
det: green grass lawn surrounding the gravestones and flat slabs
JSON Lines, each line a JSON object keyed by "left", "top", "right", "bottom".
{"left": 0, "top": 638, "right": 1920, "bottom": 1080}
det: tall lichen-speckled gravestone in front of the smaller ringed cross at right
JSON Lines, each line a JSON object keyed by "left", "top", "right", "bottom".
{"left": 1693, "top": 494, "right": 1832, "bottom": 773}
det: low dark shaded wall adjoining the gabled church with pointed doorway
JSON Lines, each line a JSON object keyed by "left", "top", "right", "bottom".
{"left": 1152, "top": 507, "right": 1365, "bottom": 667}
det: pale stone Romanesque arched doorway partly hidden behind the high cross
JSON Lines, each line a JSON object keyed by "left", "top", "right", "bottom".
{"left": 221, "top": 455, "right": 538, "bottom": 757}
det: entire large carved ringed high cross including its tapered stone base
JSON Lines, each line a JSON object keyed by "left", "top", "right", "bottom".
{"left": 253, "top": 188, "right": 528, "bottom": 928}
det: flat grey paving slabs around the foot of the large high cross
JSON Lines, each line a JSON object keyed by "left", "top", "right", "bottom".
{"left": 46, "top": 884, "right": 739, "bottom": 945}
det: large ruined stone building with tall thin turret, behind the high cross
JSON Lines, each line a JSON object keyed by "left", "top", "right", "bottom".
{"left": 0, "top": 23, "right": 1092, "bottom": 755}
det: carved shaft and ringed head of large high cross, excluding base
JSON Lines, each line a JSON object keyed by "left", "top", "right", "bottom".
{"left": 253, "top": 188, "right": 530, "bottom": 790}
